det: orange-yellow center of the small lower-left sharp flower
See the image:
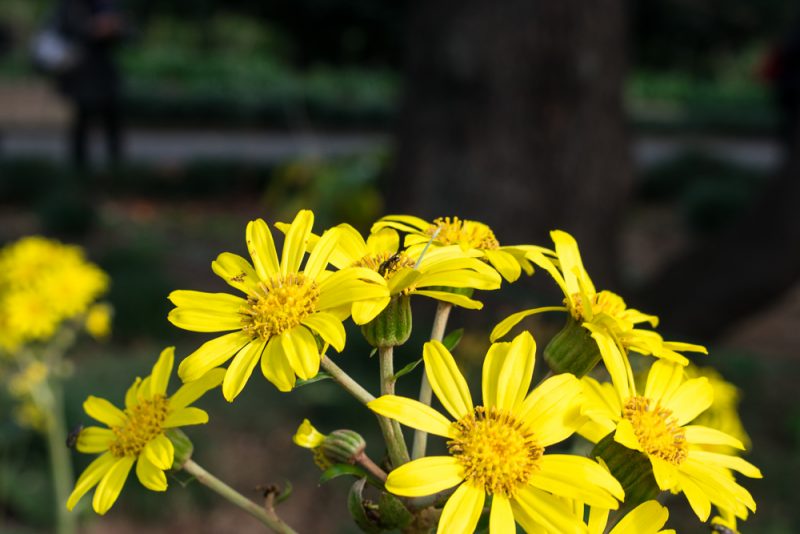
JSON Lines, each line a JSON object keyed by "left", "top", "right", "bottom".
{"left": 109, "top": 395, "right": 169, "bottom": 458}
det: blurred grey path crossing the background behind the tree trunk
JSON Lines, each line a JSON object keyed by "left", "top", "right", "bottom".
{"left": 2, "top": 127, "right": 781, "bottom": 170}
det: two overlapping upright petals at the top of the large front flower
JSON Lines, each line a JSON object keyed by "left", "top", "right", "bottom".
{"left": 482, "top": 332, "right": 536, "bottom": 412}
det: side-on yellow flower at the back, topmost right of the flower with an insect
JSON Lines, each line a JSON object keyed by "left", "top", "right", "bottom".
{"left": 372, "top": 215, "right": 539, "bottom": 282}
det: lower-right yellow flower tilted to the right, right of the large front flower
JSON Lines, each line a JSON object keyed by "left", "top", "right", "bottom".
{"left": 580, "top": 360, "right": 761, "bottom": 521}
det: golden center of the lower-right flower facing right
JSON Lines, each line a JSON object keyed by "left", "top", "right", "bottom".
{"left": 622, "top": 396, "right": 689, "bottom": 465}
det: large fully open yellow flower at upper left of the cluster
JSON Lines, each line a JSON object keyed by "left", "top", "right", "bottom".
{"left": 169, "top": 210, "right": 388, "bottom": 401}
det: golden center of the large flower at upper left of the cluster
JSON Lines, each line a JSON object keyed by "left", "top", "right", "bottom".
{"left": 242, "top": 273, "right": 319, "bottom": 339}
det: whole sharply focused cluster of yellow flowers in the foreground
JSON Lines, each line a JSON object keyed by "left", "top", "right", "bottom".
{"left": 68, "top": 211, "right": 761, "bottom": 534}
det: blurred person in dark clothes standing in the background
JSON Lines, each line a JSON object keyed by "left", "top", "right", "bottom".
{"left": 56, "top": 0, "right": 127, "bottom": 170}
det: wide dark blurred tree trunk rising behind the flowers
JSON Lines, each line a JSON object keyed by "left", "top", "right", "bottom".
{"left": 389, "top": 0, "right": 632, "bottom": 287}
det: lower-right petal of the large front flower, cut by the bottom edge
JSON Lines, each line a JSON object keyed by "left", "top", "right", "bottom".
{"left": 511, "top": 486, "right": 587, "bottom": 534}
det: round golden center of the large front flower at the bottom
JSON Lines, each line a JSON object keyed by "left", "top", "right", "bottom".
{"left": 447, "top": 406, "right": 544, "bottom": 497}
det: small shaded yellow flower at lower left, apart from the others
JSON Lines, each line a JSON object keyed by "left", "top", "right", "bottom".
{"left": 67, "top": 347, "right": 223, "bottom": 515}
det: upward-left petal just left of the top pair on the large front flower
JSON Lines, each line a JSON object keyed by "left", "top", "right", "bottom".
{"left": 422, "top": 341, "right": 473, "bottom": 420}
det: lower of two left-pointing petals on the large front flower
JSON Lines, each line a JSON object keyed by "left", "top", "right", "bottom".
{"left": 386, "top": 456, "right": 464, "bottom": 497}
